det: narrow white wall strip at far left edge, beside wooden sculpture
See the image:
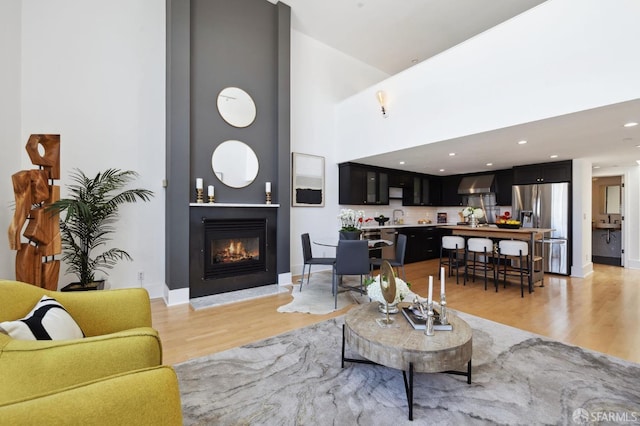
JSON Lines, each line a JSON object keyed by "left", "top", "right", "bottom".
{"left": 0, "top": 0, "right": 21, "bottom": 279}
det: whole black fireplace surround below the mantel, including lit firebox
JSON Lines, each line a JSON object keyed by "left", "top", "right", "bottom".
{"left": 189, "top": 206, "right": 277, "bottom": 298}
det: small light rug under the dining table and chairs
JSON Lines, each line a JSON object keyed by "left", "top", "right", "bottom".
{"left": 278, "top": 271, "right": 369, "bottom": 315}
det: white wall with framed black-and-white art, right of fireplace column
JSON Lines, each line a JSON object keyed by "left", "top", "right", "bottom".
{"left": 285, "top": 31, "right": 388, "bottom": 275}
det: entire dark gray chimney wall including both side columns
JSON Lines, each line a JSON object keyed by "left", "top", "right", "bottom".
{"left": 166, "top": 0, "right": 291, "bottom": 289}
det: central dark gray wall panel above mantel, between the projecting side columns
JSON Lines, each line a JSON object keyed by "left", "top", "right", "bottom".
{"left": 191, "top": 0, "right": 278, "bottom": 203}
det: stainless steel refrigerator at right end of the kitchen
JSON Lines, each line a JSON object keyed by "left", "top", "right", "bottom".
{"left": 512, "top": 182, "right": 571, "bottom": 275}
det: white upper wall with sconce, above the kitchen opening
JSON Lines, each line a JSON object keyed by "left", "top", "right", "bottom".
{"left": 337, "top": 0, "right": 640, "bottom": 162}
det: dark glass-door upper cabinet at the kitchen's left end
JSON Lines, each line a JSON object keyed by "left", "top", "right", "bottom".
{"left": 338, "top": 163, "right": 389, "bottom": 205}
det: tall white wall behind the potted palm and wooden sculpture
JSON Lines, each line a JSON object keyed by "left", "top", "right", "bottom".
{"left": 10, "top": 0, "right": 166, "bottom": 295}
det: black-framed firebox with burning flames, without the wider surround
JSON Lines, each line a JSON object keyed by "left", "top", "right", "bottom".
{"left": 203, "top": 219, "right": 267, "bottom": 280}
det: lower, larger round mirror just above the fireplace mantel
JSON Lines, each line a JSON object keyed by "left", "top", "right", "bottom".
{"left": 211, "top": 140, "right": 258, "bottom": 188}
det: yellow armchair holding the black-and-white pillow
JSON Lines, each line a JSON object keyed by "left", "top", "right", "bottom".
{"left": 0, "top": 280, "right": 162, "bottom": 406}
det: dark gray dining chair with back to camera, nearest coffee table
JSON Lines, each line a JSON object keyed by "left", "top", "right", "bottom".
{"left": 332, "top": 240, "right": 369, "bottom": 309}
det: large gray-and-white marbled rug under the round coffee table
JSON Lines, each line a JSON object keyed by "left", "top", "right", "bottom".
{"left": 175, "top": 310, "right": 640, "bottom": 426}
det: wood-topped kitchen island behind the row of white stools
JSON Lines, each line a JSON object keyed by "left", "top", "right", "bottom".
{"left": 438, "top": 225, "right": 553, "bottom": 291}
